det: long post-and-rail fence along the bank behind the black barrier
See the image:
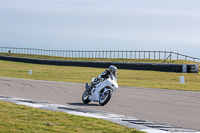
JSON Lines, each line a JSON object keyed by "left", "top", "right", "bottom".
{"left": 0, "top": 47, "right": 200, "bottom": 63}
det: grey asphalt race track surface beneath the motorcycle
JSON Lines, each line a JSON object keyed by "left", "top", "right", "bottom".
{"left": 0, "top": 77, "right": 200, "bottom": 130}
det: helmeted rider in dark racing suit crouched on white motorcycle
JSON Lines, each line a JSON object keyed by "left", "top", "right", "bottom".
{"left": 87, "top": 65, "right": 117, "bottom": 92}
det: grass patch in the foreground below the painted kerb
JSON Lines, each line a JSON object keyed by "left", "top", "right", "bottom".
{"left": 0, "top": 101, "right": 142, "bottom": 133}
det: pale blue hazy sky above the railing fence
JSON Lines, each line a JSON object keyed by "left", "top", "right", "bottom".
{"left": 0, "top": 0, "right": 200, "bottom": 58}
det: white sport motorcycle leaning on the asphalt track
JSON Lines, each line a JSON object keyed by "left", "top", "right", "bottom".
{"left": 82, "top": 75, "right": 119, "bottom": 106}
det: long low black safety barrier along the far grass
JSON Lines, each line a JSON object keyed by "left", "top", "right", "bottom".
{"left": 0, "top": 56, "right": 198, "bottom": 73}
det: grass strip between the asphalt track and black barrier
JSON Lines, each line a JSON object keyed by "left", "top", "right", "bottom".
{"left": 0, "top": 61, "right": 200, "bottom": 91}
